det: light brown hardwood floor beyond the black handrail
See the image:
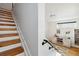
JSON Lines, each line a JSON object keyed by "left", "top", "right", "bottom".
{"left": 49, "top": 38, "right": 79, "bottom": 56}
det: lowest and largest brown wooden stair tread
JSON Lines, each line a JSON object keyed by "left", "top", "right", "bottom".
{"left": 0, "top": 47, "right": 24, "bottom": 56}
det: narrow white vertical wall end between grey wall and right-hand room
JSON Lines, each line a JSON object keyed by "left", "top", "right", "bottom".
{"left": 38, "top": 3, "right": 48, "bottom": 56}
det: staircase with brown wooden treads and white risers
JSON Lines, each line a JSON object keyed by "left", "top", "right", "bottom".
{"left": 0, "top": 8, "right": 25, "bottom": 56}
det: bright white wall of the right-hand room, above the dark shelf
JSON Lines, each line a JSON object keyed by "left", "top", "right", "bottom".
{"left": 45, "top": 3, "right": 79, "bottom": 37}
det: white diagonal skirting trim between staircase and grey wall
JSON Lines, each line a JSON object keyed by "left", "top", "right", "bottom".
{"left": 12, "top": 7, "right": 31, "bottom": 56}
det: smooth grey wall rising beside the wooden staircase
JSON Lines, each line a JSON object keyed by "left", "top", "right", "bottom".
{"left": 14, "top": 3, "right": 38, "bottom": 56}
